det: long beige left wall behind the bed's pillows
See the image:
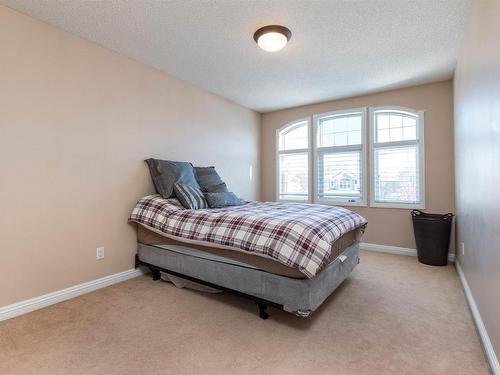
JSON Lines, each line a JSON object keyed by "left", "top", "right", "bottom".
{"left": 0, "top": 6, "right": 260, "bottom": 306}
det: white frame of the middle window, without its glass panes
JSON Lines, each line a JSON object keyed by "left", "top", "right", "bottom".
{"left": 311, "top": 107, "right": 368, "bottom": 207}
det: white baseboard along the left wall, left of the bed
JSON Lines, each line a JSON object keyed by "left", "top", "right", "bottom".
{"left": 0, "top": 268, "right": 143, "bottom": 322}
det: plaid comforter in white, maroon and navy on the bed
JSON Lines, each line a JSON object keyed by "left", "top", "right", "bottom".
{"left": 129, "top": 195, "right": 366, "bottom": 278}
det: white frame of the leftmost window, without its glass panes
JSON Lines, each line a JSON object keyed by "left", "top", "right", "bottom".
{"left": 275, "top": 117, "right": 312, "bottom": 203}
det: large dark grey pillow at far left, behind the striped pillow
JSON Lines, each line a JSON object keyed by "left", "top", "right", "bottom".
{"left": 146, "top": 159, "right": 200, "bottom": 198}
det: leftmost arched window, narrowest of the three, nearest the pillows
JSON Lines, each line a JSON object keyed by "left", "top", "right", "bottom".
{"left": 276, "top": 119, "right": 310, "bottom": 201}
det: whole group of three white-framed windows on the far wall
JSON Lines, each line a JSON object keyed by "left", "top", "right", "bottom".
{"left": 276, "top": 107, "right": 425, "bottom": 212}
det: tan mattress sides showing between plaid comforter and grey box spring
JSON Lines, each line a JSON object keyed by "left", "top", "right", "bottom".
{"left": 137, "top": 224, "right": 362, "bottom": 279}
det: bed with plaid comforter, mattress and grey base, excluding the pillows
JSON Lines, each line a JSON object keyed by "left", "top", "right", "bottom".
{"left": 129, "top": 195, "right": 367, "bottom": 319}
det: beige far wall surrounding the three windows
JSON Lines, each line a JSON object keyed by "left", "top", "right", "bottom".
{"left": 261, "top": 81, "right": 454, "bottom": 253}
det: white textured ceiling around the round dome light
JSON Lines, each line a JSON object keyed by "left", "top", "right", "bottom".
{"left": 0, "top": 0, "right": 469, "bottom": 112}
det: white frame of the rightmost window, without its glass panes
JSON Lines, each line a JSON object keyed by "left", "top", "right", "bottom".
{"left": 369, "top": 106, "right": 425, "bottom": 209}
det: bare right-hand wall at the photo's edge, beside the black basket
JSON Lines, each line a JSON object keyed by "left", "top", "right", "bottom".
{"left": 455, "top": 0, "right": 500, "bottom": 364}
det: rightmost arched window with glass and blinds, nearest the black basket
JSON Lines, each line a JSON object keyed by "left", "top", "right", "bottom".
{"left": 370, "top": 107, "right": 425, "bottom": 208}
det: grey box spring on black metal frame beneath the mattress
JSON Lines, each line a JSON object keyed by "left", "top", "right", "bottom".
{"left": 135, "top": 242, "right": 359, "bottom": 319}
